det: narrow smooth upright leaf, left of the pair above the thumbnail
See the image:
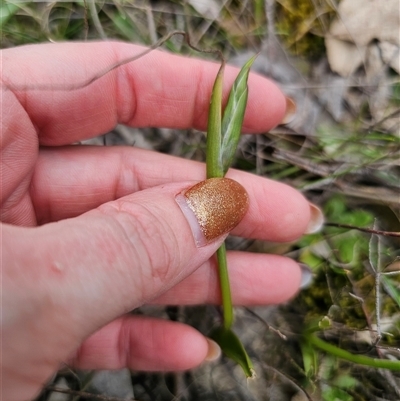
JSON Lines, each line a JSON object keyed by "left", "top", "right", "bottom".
{"left": 206, "top": 62, "right": 225, "bottom": 178}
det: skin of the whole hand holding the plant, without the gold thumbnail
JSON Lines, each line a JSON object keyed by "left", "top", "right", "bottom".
{"left": 1, "top": 42, "right": 310, "bottom": 401}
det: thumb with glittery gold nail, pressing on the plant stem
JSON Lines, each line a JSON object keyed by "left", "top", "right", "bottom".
{"left": 3, "top": 178, "right": 248, "bottom": 336}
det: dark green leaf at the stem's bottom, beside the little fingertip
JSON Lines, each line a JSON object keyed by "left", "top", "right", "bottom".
{"left": 210, "top": 327, "right": 255, "bottom": 378}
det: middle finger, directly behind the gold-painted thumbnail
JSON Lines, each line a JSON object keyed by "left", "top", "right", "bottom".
{"left": 31, "top": 146, "right": 310, "bottom": 241}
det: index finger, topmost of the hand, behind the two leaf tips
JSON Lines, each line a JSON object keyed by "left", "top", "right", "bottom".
{"left": 2, "top": 42, "right": 286, "bottom": 146}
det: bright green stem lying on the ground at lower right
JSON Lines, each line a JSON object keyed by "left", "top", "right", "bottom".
{"left": 305, "top": 335, "right": 400, "bottom": 371}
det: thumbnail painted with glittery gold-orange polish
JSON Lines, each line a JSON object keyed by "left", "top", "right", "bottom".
{"left": 176, "top": 178, "right": 249, "bottom": 247}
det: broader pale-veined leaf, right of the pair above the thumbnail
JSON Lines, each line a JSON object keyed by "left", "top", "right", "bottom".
{"left": 221, "top": 55, "right": 257, "bottom": 175}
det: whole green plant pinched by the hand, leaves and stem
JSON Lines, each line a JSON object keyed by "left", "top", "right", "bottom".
{"left": 206, "top": 53, "right": 255, "bottom": 377}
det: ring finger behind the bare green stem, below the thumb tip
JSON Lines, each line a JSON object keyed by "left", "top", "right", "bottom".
{"left": 152, "top": 251, "right": 301, "bottom": 306}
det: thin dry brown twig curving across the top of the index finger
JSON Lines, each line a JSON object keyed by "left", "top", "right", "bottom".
{"left": 7, "top": 31, "right": 225, "bottom": 91}
